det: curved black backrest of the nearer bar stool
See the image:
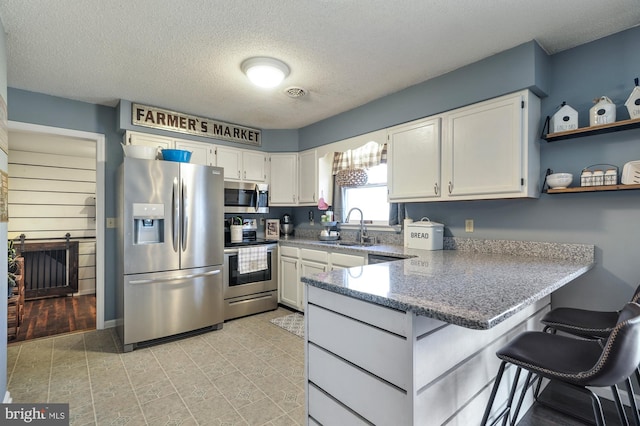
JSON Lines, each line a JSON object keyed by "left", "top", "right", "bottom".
{"left": 580, "top": 303, "right": 640, "bottom": 386}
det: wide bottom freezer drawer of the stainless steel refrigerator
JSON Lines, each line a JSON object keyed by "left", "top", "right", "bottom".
{"left": 123, "top": 266, "right": 224, "bottom": 350}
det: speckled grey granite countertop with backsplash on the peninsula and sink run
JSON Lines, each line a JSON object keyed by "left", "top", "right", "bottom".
{"left": 280, "top": 237, "right": 595, "bottom": 330}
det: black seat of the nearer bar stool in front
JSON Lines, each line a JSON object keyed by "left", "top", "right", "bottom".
{"left": 496, "top": 331, "right": 602, "bottom": 385}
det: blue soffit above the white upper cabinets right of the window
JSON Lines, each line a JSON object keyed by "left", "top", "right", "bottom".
{"left": 299, "top": 41, "right": 549, "bottom": 151}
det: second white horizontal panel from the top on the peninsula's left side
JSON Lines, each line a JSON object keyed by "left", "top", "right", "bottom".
{"left": 306, "top": 305, "right": 411, "bottom": 391}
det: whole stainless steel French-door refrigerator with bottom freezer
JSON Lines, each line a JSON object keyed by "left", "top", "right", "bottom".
{"left": 116, "top": 158, "right": 224, "bottom": 352}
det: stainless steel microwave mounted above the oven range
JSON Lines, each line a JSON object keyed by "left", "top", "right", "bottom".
{"left": 224, "top": 181, "right": 269, "bottom": 213}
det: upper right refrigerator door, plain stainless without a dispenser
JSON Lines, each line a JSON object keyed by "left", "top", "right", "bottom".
{"left": 180, "top": 163, "right": 224, "bottom": 269}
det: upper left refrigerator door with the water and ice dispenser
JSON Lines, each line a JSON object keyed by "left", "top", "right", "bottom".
{"left": 121, "top": 157, "right": 180, "bottom": 274}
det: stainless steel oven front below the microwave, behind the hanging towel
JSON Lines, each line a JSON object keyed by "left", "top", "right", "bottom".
{"left": 223, "top": 241, "right": 278, "bottom": 320}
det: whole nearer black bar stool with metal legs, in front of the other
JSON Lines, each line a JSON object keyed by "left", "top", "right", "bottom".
{"left": 481, "top": 303, "right": 640, "bottom": 426}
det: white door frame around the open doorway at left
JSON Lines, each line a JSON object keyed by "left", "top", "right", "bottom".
{"left": 8, "top": 121, "right": 106, "bottom": 330}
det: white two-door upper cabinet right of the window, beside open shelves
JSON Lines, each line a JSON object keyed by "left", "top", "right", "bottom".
{"left": 387, "top": 90, "right": 540, "bottom": 202}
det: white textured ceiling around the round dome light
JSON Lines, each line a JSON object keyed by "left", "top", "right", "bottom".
{"left": 0, "top": 0, "right": 640, "bottom": 129}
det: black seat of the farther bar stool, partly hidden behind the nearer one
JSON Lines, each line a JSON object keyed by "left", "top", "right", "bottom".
{"left": 540, "top": 308, "right": 620, "bottom": 338}
